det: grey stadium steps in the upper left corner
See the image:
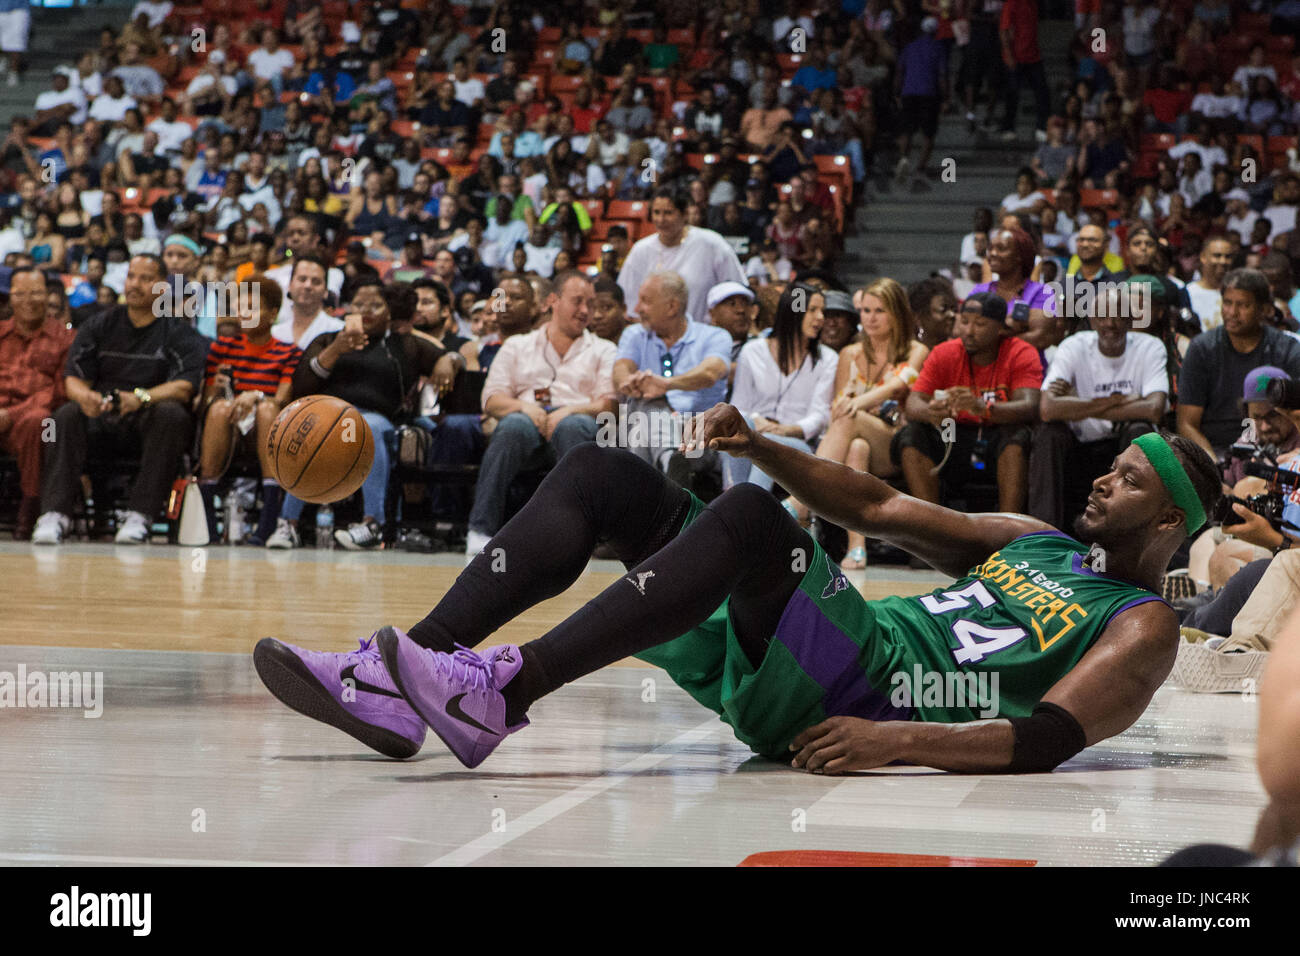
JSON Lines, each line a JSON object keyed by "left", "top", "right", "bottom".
{"left": 0, "top": 4, "right": 130, "bottom": 130}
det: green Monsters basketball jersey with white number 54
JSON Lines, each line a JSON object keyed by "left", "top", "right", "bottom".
{"left": 863, "top": 532, "right": 1160, "bottom": 723}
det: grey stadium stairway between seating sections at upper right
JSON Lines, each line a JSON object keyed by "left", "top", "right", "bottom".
{"left": 839, "top": 21, "right": 1073, "bottom": 287}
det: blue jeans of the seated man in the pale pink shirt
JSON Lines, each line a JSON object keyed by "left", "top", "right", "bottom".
{"left": 467, "top": 411, "right": 597, "bottom": 535}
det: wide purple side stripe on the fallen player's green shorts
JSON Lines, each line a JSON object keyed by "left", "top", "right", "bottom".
{"left": 776, "top": 589, "right": 911, "bottom": 721}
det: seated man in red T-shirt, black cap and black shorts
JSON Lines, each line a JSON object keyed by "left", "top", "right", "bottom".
{"left": 889, "top": 293, "right": 1043, "bottom": 512}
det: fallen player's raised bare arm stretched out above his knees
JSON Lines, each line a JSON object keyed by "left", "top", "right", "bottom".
{"left": 686, "top": 405, "right": 1050, "bottom": 578}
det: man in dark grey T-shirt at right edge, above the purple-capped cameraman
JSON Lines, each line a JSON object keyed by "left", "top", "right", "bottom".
{"left": 1178, "top": 269, "right": 1300, "bottom": 457}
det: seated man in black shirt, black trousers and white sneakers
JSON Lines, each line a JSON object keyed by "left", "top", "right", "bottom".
{"left": 31, "top": 255, "right": 208, "bottom": 544}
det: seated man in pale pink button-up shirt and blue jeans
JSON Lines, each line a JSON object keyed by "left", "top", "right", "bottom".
{"left": 465, "top": 272, "right": 618, "bottom": 563}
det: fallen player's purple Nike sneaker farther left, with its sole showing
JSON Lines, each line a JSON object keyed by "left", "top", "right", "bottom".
{"left": 252, "top": 631, "right": 425, "bottom": 758}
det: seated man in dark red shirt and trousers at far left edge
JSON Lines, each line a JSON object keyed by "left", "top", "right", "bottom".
{"left": 0, "top": 268, "right": 73, "bottom": 541}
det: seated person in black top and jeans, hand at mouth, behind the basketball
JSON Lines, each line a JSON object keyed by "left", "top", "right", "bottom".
{"left": 267, "top": 277, "right": 454, "bottom": 550}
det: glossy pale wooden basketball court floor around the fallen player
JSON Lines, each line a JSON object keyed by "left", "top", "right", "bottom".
{"left": 0, "top": 544, "right": 1264, "bottom": 866}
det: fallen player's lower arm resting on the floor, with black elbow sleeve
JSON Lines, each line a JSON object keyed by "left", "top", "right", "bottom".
{"left": 790, "top": 601, "right": 1178, "bottom": 774}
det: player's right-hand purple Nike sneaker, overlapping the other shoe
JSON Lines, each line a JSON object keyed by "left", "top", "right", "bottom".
{"left": 376, "top": 627, "right": 528, "bottom": 769}
